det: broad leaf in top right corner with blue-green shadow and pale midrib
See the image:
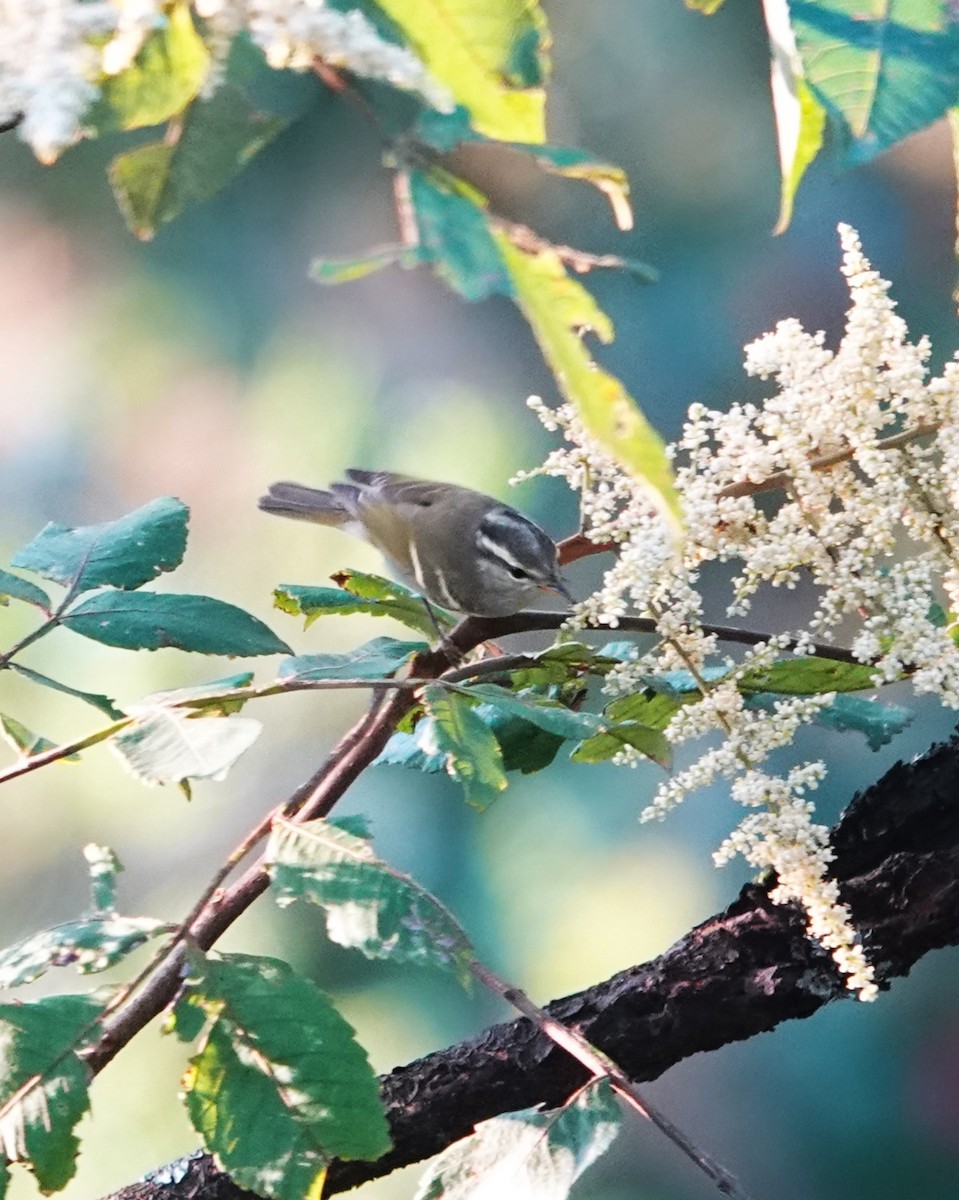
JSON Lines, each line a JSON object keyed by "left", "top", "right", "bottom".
{"left": 789, "top": 0, "right": 959, "bottom": 166}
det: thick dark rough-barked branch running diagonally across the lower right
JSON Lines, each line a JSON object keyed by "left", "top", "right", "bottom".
{"left": 99, "top": 720, "right": 959, "bottom": 1200}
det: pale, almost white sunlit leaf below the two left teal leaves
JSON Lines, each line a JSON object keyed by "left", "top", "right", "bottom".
{"left": 110, "top": 708, "right": 263, "bottom": 784}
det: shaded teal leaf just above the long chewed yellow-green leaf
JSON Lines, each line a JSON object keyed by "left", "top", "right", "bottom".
{"left": 407, "top": 170, "right": 515, "bottom": 300}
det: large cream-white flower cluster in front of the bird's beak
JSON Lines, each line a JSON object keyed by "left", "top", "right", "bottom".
{"left": 520, "top": 226, "right": 959, "bottom": 1000}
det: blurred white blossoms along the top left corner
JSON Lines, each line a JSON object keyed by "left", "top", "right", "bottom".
{"left": 0, "top": 0, "right": 454, "bottom": 162}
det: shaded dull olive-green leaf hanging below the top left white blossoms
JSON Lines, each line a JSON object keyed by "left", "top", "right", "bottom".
{"left": 109, "top": 84, "right": 289, "bottom": 240}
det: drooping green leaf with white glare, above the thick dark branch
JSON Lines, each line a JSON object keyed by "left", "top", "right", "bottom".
{"left": 265, "top": 821, "right": 473, "bottom": 984}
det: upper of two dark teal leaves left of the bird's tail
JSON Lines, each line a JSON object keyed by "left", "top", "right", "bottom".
{"left": 12, "top": 496, "right": 190, "bottom": 594}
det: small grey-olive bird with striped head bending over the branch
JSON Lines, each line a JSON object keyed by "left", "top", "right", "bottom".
{"left": 259, "top": 470, "right": 573, "bottom": 617}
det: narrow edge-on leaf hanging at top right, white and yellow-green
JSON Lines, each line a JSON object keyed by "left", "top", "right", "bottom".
{"left": 763, "top": 0, "right": 826, "bottom": 234}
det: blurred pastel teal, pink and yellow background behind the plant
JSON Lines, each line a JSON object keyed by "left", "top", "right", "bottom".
{"left": 0, "top": 0, "right": 959, "bottom": 1200}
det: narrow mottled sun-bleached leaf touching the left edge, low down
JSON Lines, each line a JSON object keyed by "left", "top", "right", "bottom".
{"left": 0, "top": 913, "right": 169, "bottom": 988}
